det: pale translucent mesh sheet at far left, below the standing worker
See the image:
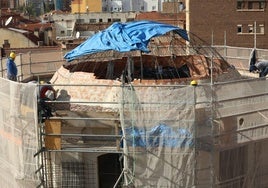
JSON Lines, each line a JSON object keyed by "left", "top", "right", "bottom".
{"left": 0, "top": 79, "right": 38, "bottom": 188}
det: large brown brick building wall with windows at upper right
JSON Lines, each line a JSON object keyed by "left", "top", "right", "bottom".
{"left": 186, "top": 0, "right": 268, "bottom": 48}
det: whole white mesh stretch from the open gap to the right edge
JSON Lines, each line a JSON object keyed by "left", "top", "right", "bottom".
{"left": 120, "top": 79, "right": 268, "bottom": 188}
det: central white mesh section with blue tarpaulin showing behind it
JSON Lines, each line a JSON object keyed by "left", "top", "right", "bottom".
{"left": 121, "top": 86, "right": 195, "bottom": 187}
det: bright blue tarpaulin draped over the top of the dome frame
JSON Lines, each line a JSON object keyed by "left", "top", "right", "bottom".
{"left": 64, "top": 21, "right": 188, "bottom": 61}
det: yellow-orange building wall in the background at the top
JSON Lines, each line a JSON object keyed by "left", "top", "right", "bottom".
{"left": 71, "top": 0, "right": 102, "bottom": 13}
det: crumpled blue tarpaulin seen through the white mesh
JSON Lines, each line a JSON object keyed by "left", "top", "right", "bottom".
{"left": 122, "top": 124, "right": 193, "bottom": 148}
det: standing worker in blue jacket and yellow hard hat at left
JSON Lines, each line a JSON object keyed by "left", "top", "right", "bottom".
{"left": 6, "top": 52, "right": 18, "bottom": 81}
